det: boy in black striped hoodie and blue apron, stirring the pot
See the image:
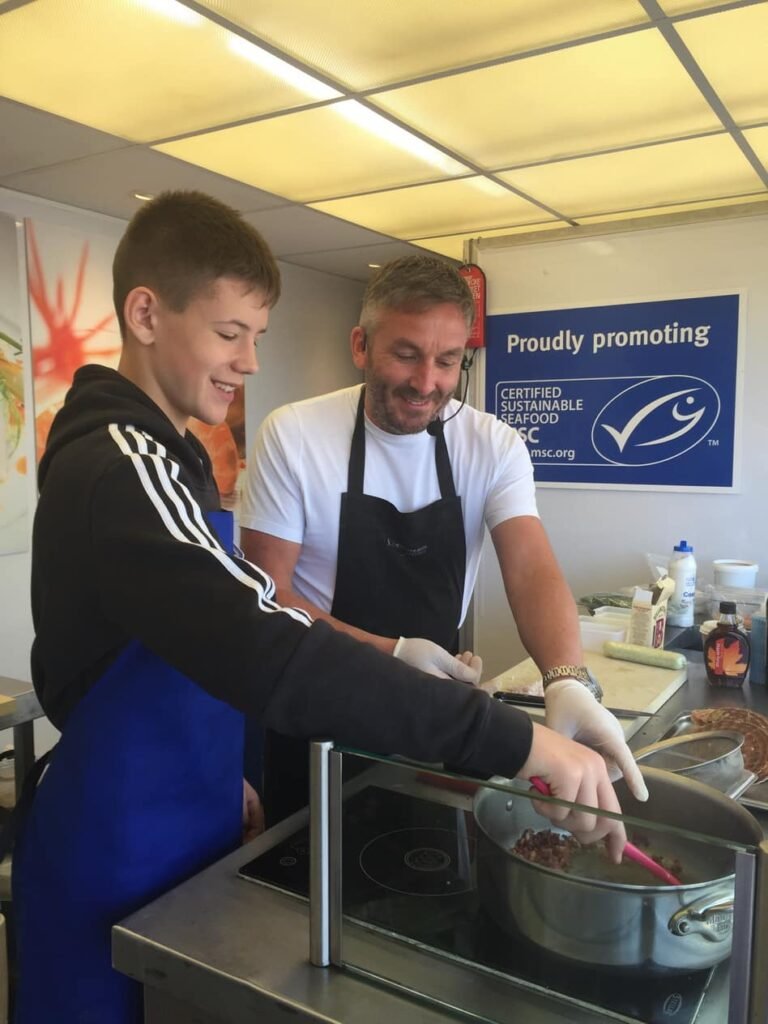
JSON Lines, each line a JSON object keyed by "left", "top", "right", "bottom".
{"left": 13, "top": 193, "right": 625, "bottom": 1024}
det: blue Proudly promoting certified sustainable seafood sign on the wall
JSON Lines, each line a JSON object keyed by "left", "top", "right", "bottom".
{"left": 485, "top": 295, "right": 739, "bottom": 489}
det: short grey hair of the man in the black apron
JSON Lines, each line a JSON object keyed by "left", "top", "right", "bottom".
{"left": 360, "top": 254, "right": 475, "bottom": 335}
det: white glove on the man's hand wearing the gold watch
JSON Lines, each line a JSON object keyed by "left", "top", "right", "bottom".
{"left": 544, "top": 679, "right": 648, "bottom": 801}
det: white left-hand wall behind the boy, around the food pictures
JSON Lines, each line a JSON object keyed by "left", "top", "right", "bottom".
{"left": 0, "top": 188, "right": 362, "bottom": 753}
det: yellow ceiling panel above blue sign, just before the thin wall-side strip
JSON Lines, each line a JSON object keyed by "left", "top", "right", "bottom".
{"left": 500, "top": 134, "right": 762, "bottom": 217}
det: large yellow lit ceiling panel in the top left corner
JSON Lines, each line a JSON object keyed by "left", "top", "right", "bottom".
{"left": 0, "top": 0, "right": 338, "bottom": 141}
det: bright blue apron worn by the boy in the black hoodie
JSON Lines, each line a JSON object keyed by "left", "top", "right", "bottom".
{"left": 12, "top": 512, "right": 243, "bottom": 1024}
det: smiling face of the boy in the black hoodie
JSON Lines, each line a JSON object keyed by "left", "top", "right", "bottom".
{"left": 144, "top": 278, "right": 269, "bottom": 433}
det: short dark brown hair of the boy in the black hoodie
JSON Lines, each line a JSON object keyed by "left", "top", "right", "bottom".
{"left": 112, "top": 191, "right": 281, "bottom": 337}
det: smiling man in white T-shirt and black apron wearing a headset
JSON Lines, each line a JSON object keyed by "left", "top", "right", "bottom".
{"left": 241, "top": 255, "right": 645, "bottom": 819}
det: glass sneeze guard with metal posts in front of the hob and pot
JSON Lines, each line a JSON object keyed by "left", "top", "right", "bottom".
{"left": 309, "top": 742, "right": 766, "bottom": 1024}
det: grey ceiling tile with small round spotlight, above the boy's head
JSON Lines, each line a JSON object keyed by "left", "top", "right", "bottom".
{"left": 2, "top": 143, "right": 285, "bottom": 218}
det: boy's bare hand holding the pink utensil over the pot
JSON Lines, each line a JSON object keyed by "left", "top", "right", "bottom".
{"left": 517, "top": 724, "right": 627, "bottom": 864}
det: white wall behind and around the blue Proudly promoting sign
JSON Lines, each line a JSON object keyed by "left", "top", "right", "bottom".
{"left": 474, "top": 213, "right": 768, "bottom": 676}
